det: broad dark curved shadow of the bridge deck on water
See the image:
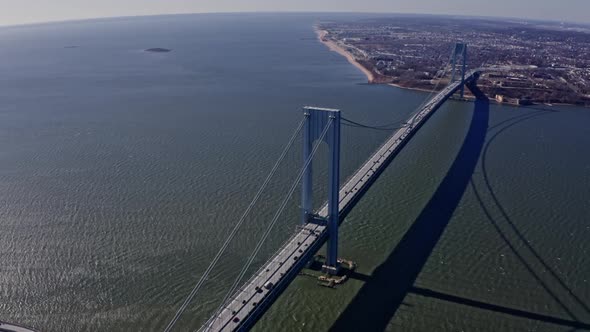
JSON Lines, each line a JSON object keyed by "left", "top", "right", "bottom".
{"left": 330, "top": 95, "right": 490, "bottom": 331}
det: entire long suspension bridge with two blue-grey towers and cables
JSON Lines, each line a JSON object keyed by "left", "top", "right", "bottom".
{"left": 165, "top": 43, "right": 479, "bottom": 332}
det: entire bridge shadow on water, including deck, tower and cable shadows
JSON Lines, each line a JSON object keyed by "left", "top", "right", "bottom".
{"left": 330, "top": 99, "right": 590, "bottom": 331}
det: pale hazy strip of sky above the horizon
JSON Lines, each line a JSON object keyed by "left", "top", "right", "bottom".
{"left": 0, "top": 0, "right": 590, "bottom": 25}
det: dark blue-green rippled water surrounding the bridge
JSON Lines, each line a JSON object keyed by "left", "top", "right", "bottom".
{"left": 0, "top": 14, "right": 590, "bottom": 331}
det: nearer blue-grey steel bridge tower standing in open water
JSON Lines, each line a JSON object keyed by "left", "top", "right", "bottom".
{"left": 301, "top": 107, "right": 340, "bottom": 274}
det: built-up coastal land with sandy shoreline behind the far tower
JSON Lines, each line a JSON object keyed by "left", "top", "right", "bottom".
{"left": 316, "top": 15, "right": 590, "bottom": 106}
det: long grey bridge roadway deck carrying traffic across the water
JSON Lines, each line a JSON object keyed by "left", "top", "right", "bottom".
{"left": 200, "top": 71, "right": 477, "bottom": 331}
